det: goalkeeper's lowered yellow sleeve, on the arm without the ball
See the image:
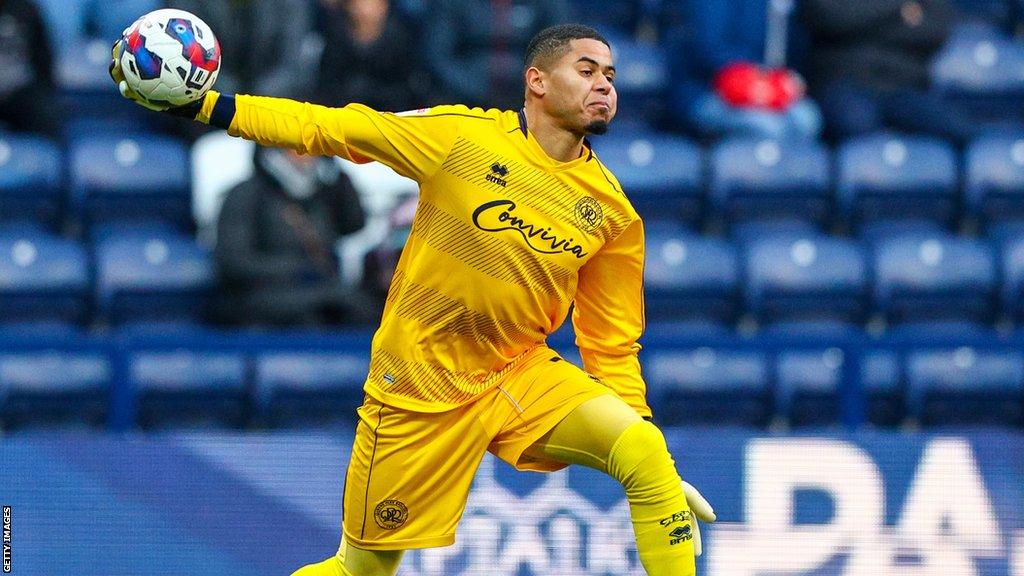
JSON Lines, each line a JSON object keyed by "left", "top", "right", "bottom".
{"left": 572, "top": 220, "right": 651, "bottom": 416}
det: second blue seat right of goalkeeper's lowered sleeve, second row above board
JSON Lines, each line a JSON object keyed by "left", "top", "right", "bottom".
{"left": 743, "top": 236, "right": 868, "bottom": 322}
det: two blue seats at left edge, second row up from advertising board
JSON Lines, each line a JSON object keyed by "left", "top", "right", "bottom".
{"left": 0, "top": 224, "right": 214, "bottom": 325}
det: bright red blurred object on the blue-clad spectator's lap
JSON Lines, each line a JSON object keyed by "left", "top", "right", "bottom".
{"left": 714, "top": 61, "right": 805, "bottom": 111}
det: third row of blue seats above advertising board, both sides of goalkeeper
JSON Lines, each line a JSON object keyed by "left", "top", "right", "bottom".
{"left": 6, "top": 127, "right": 1024, "bottom": 233}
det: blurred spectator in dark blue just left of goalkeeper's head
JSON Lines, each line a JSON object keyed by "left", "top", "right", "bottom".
{"left": 424, "top": 0, "right": 569, "bottom": 110}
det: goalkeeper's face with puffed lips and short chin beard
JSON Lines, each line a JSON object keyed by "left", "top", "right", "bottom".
{"left": 544, "top": 38, "right": 618, "bottom": 134}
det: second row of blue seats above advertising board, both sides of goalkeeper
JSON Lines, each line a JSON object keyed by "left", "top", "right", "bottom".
{"left": 6, "top": 222, "right": 1024, "bottom": 325}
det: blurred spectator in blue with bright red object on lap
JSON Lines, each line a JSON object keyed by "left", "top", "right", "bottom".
{"left": 669, "top": 0, "right": 821, "bottom": 138}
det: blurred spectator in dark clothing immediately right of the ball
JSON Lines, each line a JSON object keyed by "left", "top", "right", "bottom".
{"left": 167, "top": 0, "right": 319, "bottom": 99}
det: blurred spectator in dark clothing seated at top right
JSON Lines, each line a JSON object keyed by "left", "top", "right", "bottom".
{"left": 801, "top": 0, "right": 1011, "bottom": 142}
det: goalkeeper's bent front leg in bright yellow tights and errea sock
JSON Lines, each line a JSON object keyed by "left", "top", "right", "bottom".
{"left": 526, "top": 394, "right": 696, "bottom": 576}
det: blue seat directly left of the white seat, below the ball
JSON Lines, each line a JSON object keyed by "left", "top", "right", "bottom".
{"left": 69, "top": 135, "right": 191, "bottom": 230}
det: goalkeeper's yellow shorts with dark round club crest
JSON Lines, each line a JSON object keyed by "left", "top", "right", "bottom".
{"left": 342, "top": 346, "right": 614, "bottom": 550}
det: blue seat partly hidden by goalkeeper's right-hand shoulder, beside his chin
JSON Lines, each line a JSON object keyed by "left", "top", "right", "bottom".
{"left": 594, "top": 130, "right": 705, "bottom": 224}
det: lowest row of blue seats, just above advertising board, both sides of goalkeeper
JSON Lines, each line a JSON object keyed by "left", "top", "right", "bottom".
{"left": 0, "top": 325, "right": 1024, "bottom": 428}
